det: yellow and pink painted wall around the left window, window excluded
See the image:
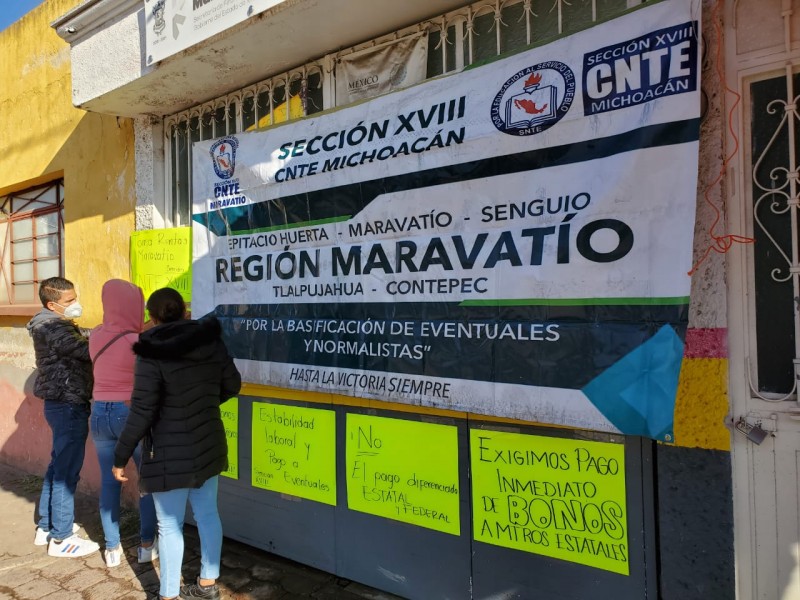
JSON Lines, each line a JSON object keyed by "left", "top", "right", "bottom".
{"left": 0, "top": 0, "right": 136, "bottom": 489}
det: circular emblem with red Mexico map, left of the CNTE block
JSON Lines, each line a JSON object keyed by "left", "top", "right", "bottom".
{"left": 492, "top": 60, "right": 575, "bottom": 135}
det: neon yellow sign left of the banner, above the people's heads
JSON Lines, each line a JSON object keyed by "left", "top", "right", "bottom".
{"left": 131, "top": 227, "right": 192, "bottom": 302}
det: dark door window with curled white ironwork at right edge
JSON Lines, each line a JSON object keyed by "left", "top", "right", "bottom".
{"left": 748, "top": 73, "right": 800, "bottom": 400}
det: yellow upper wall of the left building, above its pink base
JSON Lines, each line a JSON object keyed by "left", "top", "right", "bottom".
{"left": 0, "top": 0, "right": 136, "bottom": 330}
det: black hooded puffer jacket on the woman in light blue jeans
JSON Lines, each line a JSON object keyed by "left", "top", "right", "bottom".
{"left": 114, "top": 317, "right": 242, "bottom": 492}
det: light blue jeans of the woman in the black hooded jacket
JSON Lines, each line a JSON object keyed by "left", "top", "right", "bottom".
{"left": 153, "top": 476, "right": 222, "bottom": 598}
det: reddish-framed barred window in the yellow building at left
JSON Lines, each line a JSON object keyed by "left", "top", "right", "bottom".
{"left": 0, "top": 181, "right": 64, "bottom": 307}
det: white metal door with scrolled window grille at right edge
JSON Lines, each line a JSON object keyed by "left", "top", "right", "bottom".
{"left": 724, "top": 0, "right": 800, "bottom": 600}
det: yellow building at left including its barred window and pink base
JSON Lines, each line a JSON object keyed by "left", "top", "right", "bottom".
{"left": 0, "top": 0, "right": 136, "bottom": 496}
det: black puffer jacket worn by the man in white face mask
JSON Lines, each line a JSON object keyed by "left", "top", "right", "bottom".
{"left": 28, "top": 308, "right": 94, "bottom": 404}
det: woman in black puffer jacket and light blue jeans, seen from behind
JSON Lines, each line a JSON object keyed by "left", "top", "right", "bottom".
{"left": 114, "top": 288, "right": 241, "bottom": 598}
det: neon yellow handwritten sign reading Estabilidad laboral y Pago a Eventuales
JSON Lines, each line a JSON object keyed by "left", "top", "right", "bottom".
{"left": 252, "top": 402, "right": 336, "bottom": 506}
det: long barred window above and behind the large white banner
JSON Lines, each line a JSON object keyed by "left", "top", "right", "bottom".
{"left": 164, "top": 0, "right": 645, "bottom": 226}
